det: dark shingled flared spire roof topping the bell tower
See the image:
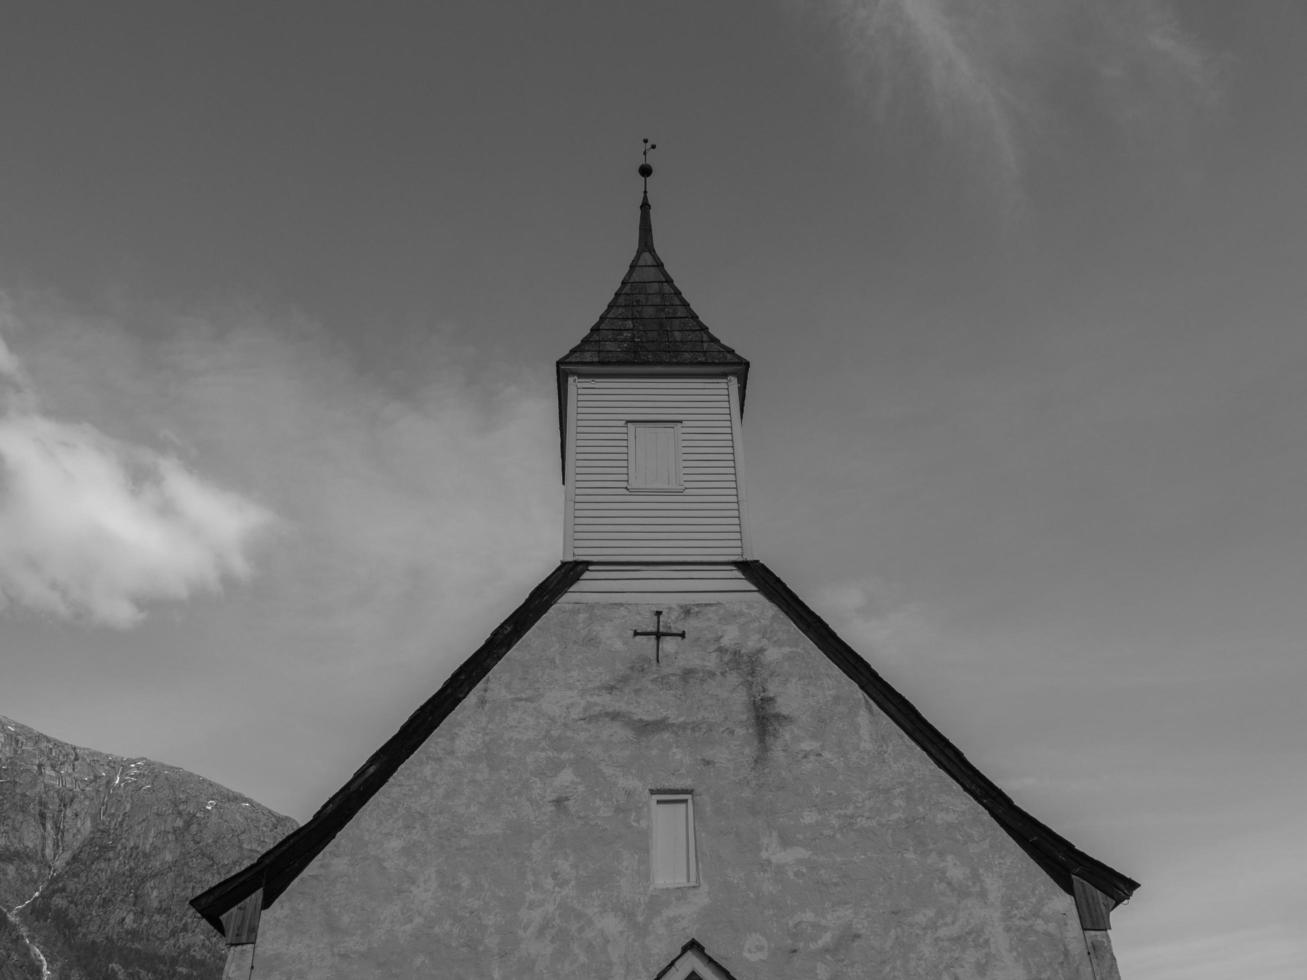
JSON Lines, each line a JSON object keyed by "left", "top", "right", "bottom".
{"left": 558, "top": 193, "right": 749, "bottom": 374}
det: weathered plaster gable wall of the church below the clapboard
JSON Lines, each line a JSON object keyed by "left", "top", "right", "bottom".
{"left": 255, "top": 597, "right": 1093, "bottom": 980}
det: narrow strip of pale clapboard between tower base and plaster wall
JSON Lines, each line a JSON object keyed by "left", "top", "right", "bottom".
{"left": 559, "top": 562, "right": 758, "bottom": 605}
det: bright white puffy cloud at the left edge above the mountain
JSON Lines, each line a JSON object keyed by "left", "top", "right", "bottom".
{"left": 0, "top": 297, "right": 272, "bottom": 627}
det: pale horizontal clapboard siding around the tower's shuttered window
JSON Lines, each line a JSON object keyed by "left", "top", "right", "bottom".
{"left": 567, "top": 378, "right": 744, "bottom": 559}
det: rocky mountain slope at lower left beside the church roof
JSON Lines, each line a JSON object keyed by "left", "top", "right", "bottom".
{"left": 0, "top": 716, "right": 295, "bottom": 980}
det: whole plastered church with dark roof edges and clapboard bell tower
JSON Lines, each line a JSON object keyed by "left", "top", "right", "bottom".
{"left": 191, "top": 162, "right": 1138, "bottom": 980}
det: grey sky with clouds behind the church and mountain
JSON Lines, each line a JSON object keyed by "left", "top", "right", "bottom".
{"left": 0, "top": 0, "right": 1307, "bottom": 980}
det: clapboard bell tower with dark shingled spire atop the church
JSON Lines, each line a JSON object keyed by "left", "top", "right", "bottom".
{"left": 558, "top": 150, "right": 753, "bottom": 601}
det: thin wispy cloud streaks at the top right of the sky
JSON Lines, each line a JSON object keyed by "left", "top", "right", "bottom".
{"left": 809, "top": 0, "right": 1218, "bottom": 195}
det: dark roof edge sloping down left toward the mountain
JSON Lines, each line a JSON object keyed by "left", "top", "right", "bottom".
{"left": 191, "top": 562, "right": 589, "bottom": 934}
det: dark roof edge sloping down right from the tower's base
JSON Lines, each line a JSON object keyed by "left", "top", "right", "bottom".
{"left": 736, "top": 561, "right": 1138, "bottom": 907}
